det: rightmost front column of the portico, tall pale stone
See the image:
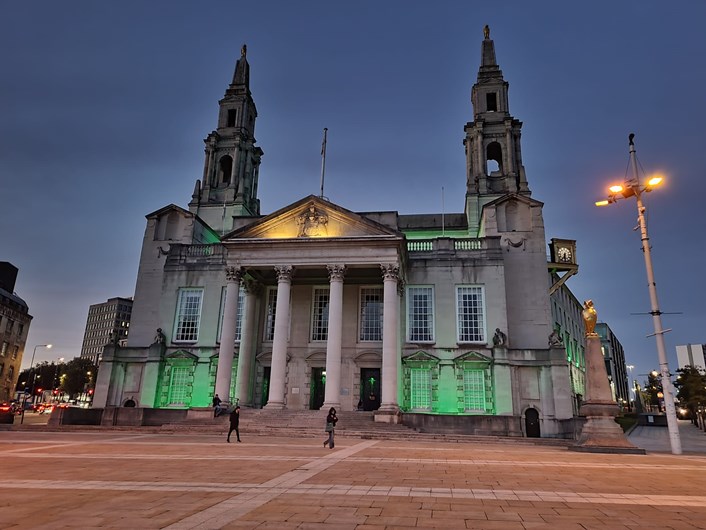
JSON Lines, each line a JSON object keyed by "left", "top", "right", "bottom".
{"left": 380, "top": 264, "right": 400, "bottom": 412}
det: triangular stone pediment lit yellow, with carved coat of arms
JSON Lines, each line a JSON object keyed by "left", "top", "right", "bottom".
{"left": 223, "top": 195, "right": 402, "bottom": 241}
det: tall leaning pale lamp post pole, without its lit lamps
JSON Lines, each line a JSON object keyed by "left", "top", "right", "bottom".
{"left": 630, "top": 135, "right": 682, "bottom": 455}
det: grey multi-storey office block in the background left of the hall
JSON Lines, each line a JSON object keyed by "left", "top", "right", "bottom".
{"left": 81, "top": 297, "right": 132, "bottom": 363}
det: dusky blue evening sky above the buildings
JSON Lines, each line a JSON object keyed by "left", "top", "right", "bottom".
{"left": 0, "top": 0, "right": 706, "bottom": 382}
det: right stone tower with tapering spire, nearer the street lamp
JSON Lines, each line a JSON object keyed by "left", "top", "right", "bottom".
{"left": 463, "top": 25, "right": 530, "bottom": 231}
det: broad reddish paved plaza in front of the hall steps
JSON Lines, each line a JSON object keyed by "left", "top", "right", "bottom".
{"left": 0, "top": 425, "right": 706, "bottom": 530}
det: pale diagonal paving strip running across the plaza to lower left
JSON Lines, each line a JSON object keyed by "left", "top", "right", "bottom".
{"left": 165, "top": 441, "right": 378, "bottom": 530}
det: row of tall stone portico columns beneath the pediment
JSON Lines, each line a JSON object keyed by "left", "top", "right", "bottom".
{"left": 215, "top": 264, "right": 400, "bottom": 411}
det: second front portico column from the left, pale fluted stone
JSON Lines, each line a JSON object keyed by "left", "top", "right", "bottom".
{"left": 265, "top": 265, "right": 294, "bottom": 409}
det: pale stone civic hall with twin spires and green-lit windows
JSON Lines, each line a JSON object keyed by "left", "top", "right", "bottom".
{"left": 94, "top": 32, "right": 576, "bottom": 437}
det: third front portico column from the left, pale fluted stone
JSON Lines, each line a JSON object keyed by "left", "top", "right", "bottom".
{"left": 323, "top": 265, "right": 346, "bottom": 409}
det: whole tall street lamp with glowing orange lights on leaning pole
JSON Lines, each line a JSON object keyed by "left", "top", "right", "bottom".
{"left": 596, "top": 134, "right": 682, "bottom": 455}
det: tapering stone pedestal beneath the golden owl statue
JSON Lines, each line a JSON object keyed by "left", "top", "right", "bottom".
{"left": 569, "top": 333, "right": 645, "bottom": 455}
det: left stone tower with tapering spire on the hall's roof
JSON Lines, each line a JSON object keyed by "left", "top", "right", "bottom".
{"left": 189, "top": 44, "right": 263, "bottom": 234}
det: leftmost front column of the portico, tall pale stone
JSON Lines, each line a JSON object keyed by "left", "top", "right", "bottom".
{"left": 216, "top": 267, "right": 243, "bottom": 401}
